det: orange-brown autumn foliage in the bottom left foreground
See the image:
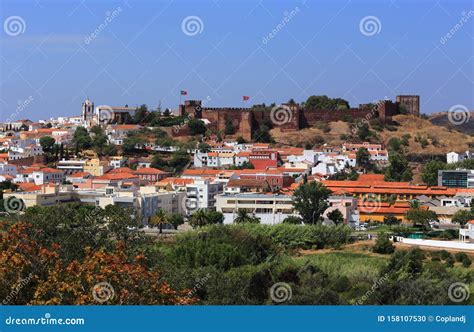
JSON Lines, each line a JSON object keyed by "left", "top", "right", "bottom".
{"left": 0, "top": 222, "right": 196, "bottom": 305}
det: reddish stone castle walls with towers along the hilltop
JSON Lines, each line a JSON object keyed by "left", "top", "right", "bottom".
{"left": 179, "top": 95, "right": 420, "bottom": 140}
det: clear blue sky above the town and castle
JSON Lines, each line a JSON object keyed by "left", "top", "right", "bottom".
{"left": 0, "top": 0, "right": 474, "bottom": 120}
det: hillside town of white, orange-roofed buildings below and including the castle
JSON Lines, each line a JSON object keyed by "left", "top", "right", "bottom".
{"left": 0, "top": 92, "right": 474, "bottom": 249}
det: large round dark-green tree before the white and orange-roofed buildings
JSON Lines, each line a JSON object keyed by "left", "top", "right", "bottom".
{"left": 293, "top": 181, "right": 331, "bottom": 224}
